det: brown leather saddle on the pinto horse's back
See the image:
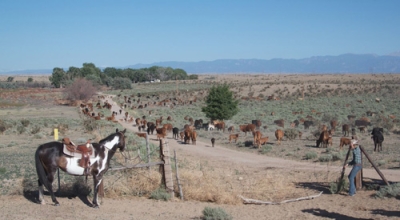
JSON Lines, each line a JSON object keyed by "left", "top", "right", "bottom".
{"left": 62, "top": 137, "right": 94, "bottom": 175}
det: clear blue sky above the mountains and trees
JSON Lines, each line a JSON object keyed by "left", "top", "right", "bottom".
{"left": 0, "top": 0, "right": 400, "bottom": 70}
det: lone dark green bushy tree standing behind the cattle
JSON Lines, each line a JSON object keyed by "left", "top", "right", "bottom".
{"left": 201, "top": 84, "right": 239, "bottom": 120}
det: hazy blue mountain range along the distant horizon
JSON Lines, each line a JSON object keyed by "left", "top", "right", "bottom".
{"left": 0, "top": 53, "right": 400, "bottom": 74}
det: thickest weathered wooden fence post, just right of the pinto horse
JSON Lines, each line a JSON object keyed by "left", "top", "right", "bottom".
{"left": 160, "top": 138, "right": 174, "bottom": 198}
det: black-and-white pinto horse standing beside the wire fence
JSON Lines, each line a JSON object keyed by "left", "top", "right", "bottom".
{"left": 35, "top": 129, "right": 126, "bottom": 208}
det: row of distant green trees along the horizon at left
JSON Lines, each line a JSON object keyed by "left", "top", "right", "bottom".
{"left": 49, "top": 63, "right": 198, "bottom": 89}
